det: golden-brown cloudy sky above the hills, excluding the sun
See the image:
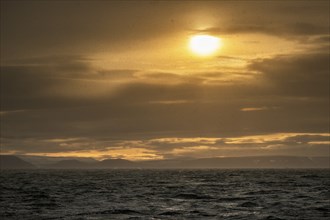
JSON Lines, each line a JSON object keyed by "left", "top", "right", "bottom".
{"left": 0, "top": 0, "right": 330, "bottom": 160}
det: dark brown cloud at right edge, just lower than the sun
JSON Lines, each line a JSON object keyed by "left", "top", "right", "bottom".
{"left": 249, "top": 53, "right": 330, "bottom": 98}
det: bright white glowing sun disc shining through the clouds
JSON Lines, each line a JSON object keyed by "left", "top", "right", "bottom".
{"left": 189, "top": 35, "right": 221, "bottom": 56}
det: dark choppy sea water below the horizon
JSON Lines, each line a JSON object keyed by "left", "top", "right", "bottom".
{"left": 0, "top": 169, "right": 330, "bottom": 220}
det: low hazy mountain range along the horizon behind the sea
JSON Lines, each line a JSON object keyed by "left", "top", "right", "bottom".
{"left": 0, "top": 155, "right": 330, "bottom": 169}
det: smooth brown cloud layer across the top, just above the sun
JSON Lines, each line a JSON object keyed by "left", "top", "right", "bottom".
{"left": 1, "top": 1, "right": 329, "bottom": 61}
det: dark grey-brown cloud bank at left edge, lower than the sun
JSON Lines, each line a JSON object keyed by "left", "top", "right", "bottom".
{"left": 0, "top": 56, "right": 136, "bottom": 111}
